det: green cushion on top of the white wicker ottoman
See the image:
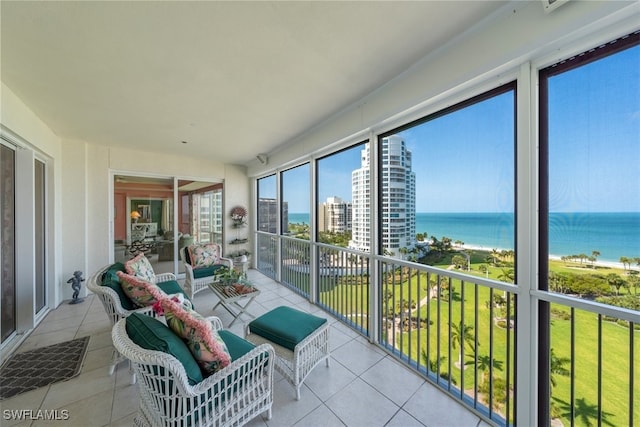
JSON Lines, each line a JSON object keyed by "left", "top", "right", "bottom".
{"left": 249, "top": 306, "right": 327, "bottom": 350}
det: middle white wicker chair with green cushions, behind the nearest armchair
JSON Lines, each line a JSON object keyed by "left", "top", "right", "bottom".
{"left": 87, "top": 262, "right": 188, "bottom": 382}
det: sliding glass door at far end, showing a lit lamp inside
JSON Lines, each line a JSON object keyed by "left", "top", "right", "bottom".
{"left": 113, "top": 175, "right": 223, "bottom": 273}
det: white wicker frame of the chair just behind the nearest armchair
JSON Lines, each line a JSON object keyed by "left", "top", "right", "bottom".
{"left": 87, "top": 265, "right": 182, "bottom": 383}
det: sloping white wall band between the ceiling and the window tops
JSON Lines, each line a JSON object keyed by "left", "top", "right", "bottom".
{"left": 248, "top": 0, "right": 640, "bottom": 176}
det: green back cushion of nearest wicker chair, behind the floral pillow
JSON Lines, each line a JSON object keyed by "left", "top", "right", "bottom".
{"left": 126, "top": 313, "right": 203, "bottom": 385}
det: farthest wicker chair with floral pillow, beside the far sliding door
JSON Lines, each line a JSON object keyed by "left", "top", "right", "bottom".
{"left": 180, "top": 243, "right": 233, "bottom": 298}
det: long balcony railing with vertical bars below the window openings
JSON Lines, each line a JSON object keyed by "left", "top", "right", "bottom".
{"left": 256, "top": 233, "right": 640, "bottom": 426}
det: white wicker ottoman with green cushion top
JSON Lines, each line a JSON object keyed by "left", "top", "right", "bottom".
{"left": 246, "top": 306, "right": 330, "bottom": 400}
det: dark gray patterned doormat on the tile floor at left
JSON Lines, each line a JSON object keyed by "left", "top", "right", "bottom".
{"left": 0, "top": 337, "right": 89, "bottom": 400}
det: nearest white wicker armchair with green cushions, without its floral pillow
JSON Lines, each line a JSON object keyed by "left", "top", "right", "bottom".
{"left": 112, "top": 316, "right": 276, "bottom": 427}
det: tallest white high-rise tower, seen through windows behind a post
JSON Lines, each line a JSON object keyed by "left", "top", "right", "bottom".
{"left": 349, "top": 135, "right": 416, "bottom": 256}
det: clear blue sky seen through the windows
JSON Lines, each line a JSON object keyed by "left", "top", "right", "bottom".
{"left": 263, "top": 47, "right": 640, "bottom": 213}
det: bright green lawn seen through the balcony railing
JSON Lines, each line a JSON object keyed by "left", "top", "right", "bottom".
{"left": 292, "top": 251, "right": 640, "bottom": 426}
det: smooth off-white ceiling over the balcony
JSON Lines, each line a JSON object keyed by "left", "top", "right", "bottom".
{"left": 0, "top": 0, "right": 506, "bottom": 164}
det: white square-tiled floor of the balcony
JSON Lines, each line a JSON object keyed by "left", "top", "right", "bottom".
{"left": 0, "top": 271, "right": 486, "bottom": 427}
